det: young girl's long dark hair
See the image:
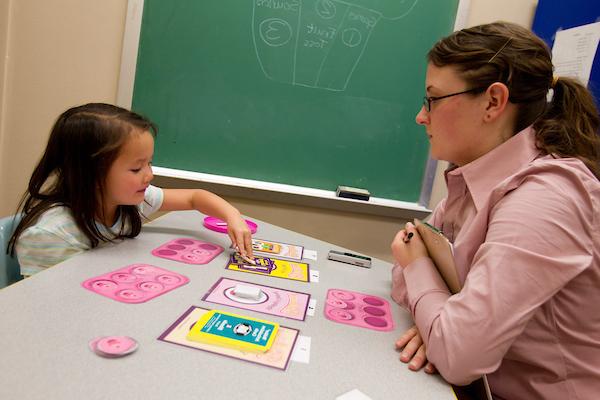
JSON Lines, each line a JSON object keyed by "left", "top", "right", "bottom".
{"left": 8, "top": 103, "right": 157, "bottom": 254}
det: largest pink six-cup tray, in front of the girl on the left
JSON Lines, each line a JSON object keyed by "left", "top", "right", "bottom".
{"left": 81, "top": 264, "right": 190, "bottom": 303}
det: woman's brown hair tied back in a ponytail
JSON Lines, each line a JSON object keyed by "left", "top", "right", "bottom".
{"left": 428, "top": 22, "right": 600, "bottom": 179}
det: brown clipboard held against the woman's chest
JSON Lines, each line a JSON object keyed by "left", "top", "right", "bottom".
{"left": 414, "top": 218, "right": 492, "bottom": 400}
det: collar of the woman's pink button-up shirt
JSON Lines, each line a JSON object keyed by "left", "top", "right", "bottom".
{"left": 446, "top": 127, "right": 541, "bottom": 211}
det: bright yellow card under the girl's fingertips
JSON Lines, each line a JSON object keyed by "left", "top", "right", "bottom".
{"left": 225, "top": 254, "right": 309, "bottom": 282}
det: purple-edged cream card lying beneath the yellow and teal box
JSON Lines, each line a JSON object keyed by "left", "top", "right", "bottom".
{"left": 158, "top": 306, "right": 300, "bottom": 370}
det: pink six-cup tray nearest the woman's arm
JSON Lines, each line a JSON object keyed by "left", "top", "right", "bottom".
{"left": 324, "top": 289, "right": 394, "bottom": 331}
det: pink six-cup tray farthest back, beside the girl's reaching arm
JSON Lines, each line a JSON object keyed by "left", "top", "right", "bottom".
{"left": 152, "top": 238, "right": 223, "bottom": 264}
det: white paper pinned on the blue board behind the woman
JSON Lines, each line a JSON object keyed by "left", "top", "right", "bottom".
{"left": 552, "top": 22, "right": 600, "bottom": 85}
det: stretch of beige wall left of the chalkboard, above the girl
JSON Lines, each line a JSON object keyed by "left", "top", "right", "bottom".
{"left": 0, "top": 0, "right": 127, "bottom": 216}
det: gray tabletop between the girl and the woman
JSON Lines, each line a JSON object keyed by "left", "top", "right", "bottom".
{"left": 0, "top": 212, "right": 454, "bottom": 400}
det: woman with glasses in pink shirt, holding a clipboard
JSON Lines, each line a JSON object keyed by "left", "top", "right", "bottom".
{"left": 392, "top": 22, "right": 600, "bottom": 400}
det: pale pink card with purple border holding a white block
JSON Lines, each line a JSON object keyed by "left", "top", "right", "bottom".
{"left": 202, "top": 278, "right": 310, "bottom": 321}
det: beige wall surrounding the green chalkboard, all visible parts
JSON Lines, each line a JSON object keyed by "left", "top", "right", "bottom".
{"left": 0, "top": 0, "right": 537, "bottom": 260}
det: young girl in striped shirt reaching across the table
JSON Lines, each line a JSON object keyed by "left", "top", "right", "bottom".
{"left": 9, "top": 103, "right": 252, "bottom": 276}
